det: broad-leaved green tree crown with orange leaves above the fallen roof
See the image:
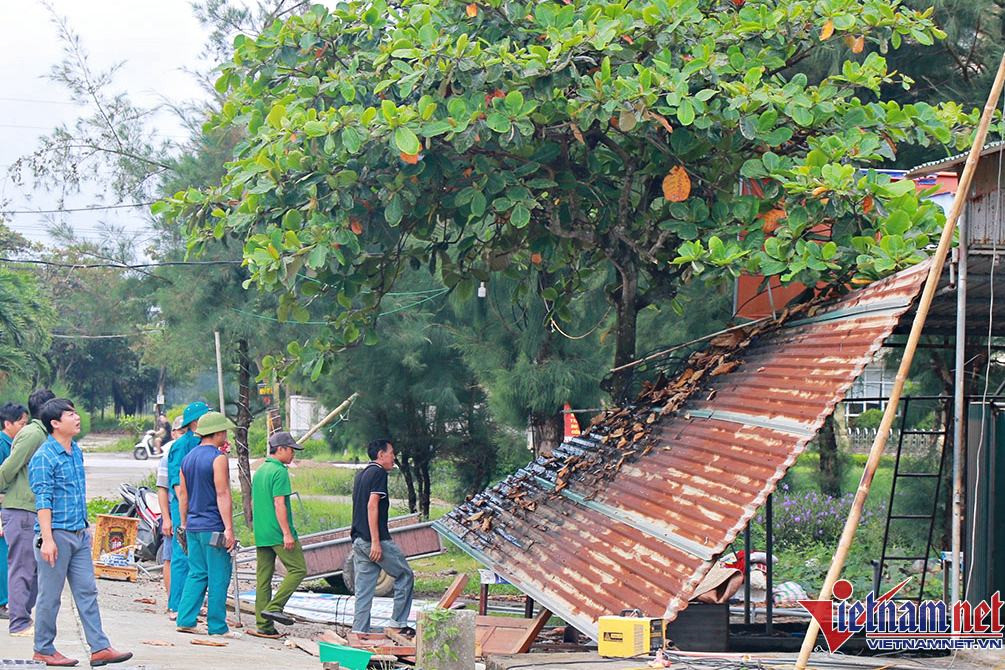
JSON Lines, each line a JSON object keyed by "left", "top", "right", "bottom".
{"left": 159, "top": 0, "right": 974, "bottom": 391}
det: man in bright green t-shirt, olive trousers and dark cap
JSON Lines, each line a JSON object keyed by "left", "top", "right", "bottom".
{"left": 251, "top": 431, "right": 308, "bottom": 638}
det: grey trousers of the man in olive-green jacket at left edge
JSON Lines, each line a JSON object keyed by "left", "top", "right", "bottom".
{"left": 0, "top": 509, "right": 38, "bottom": 633}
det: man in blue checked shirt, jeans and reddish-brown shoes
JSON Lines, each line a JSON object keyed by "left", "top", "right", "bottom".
{"left": 28, "top": 398, "right": 133, "bottom": 667}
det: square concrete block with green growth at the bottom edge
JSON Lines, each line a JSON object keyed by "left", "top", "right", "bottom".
{"left": 415, "top": 609, "right": 475, "bottom": 670}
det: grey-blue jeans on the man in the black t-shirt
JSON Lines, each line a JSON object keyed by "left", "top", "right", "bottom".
{"left": 353, "top": 537, "right": 415, "bottom": 633}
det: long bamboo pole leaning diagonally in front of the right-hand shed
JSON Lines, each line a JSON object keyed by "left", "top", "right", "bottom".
{"left": 796, "top": 49, "right": 1005, "bottom": 670}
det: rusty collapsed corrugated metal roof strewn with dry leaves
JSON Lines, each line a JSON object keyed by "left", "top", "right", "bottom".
{"left": 434, "top": 262, "right": 929, "bottom": 638}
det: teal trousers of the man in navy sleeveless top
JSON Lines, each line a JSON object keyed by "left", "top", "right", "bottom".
{"left": 177, "top": 531, "right": 231, "bottom": 635}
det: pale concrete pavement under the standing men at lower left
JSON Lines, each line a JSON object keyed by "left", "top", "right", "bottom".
{"left": 0, "top": 577, "right": 325, "bottom": 670}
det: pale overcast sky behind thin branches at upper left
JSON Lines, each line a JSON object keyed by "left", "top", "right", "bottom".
{"left": 0, "top": 0, "right": 212, "bottom": 249}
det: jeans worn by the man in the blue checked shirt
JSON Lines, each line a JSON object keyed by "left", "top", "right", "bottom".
{"left": 35, "top": 529, "right": 112, "bottom": 655}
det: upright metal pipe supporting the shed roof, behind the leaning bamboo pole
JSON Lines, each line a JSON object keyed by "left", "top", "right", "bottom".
{"left": 943, "top": 200, "right": 970, "bottom": 604}
